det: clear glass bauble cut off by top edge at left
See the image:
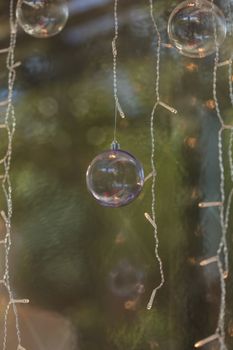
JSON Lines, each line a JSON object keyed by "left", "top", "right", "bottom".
{"left": 16, "top": 0, "right": 69, "bottom": 38}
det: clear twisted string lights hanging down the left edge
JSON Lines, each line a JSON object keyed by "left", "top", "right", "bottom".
{"left": 0, "top": 0, "right": 29, "bottom": 350}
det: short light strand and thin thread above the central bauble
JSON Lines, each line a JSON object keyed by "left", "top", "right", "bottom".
{"left": 112, "top": 0, "right": 125, "bottom": 142}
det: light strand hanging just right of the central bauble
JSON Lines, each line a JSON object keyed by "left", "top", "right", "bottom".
{"left": 145, "top": 0, "right": 177, "bottom": 310}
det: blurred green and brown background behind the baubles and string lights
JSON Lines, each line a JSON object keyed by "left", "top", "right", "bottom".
{"left": 0, "top": 0, "right": 233, "bottom": 350}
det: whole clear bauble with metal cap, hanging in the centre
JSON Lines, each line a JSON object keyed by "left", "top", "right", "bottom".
{"left": 86, "top": 142, "right": 144, "bottom": 208}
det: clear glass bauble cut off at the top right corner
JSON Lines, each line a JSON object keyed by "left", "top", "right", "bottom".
{"left": 168, "top": 0, "right": 226, "bottom": 58}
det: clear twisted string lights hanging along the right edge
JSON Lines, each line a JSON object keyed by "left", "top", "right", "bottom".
{"left": 195, "top": 0, "right": 233, "bottom": 350}
